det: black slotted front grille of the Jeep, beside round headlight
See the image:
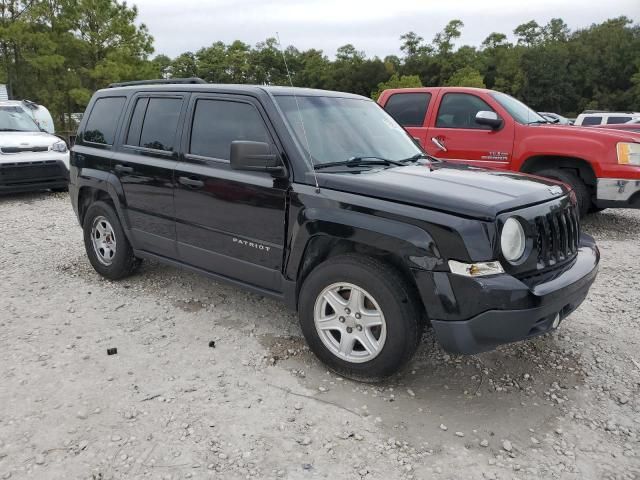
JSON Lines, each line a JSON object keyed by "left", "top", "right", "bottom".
{"left": 535, "top": 205, "right": 580, "bottom": 269}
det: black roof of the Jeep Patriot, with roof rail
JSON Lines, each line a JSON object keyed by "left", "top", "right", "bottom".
{"left": 100, "top": 83, "right": 369, "bottom": 100}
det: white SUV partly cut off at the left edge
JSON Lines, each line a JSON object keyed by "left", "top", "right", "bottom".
{"left": 0, "top": 100, "right": 69, "bottom": 193}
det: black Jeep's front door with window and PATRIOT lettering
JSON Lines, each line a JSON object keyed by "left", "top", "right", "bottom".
{"left": 175, "top": 94, "right": 288, "bottom": 292}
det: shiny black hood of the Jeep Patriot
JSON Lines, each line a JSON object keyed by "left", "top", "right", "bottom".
{"left": 318, "top": 162, "right": 570, "bottom": 220}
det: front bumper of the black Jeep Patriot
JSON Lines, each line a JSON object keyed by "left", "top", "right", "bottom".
{"left": 418, "top": 234, "right": 600, "bottom": 354}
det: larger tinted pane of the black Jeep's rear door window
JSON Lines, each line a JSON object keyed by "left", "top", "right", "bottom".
{"left": 136, "top": 98, "right": 182, "bottom": 152}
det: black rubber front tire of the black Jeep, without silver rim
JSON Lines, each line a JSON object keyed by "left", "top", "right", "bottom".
{"left": 298, "top": 254, "right": 424, "bottom": 382}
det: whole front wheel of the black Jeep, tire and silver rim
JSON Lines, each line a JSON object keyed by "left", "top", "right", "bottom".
{"left": 298, "top": 254, "right": 423, "bottom": 382}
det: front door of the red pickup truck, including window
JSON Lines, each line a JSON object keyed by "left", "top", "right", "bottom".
{"left": 425, "top": 92, "right": 515, "bottom": 169}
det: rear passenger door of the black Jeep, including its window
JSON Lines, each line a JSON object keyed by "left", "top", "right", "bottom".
{"left": 112, "top": 93, "right": 186, "bottom": 258}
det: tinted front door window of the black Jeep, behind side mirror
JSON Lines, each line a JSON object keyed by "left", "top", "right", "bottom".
{"left": 189, "top": 100, "right": 270, "bottom": 160}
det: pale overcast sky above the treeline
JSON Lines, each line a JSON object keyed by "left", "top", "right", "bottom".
{"left": 132, "top": 0, "right": 640, "bottom": 58}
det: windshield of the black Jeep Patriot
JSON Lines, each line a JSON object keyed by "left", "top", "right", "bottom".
{"left": 275, "top": 96, "right": 421, "bottom": 166}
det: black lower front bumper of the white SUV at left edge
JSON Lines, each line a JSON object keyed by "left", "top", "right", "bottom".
{"left": 0, "top": 158, "right": 69, "bottom": 194}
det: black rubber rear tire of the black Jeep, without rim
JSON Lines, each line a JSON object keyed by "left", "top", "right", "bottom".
{"left": 82, "top": 201, "right": 141, "bottom": 280}
